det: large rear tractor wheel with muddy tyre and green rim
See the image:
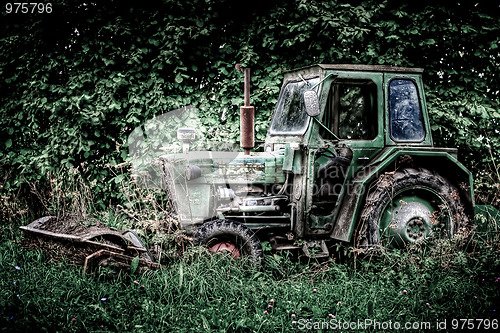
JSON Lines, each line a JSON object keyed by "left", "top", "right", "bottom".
{"left": 357, "top": 168, "right": 469, "bottom": 248}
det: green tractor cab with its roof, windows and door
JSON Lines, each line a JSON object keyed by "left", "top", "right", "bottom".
{"left": 265, "top": 64, "right": 468, "bottom": 240}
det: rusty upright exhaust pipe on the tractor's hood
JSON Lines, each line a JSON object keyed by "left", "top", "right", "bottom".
{"left": 235, "top": 64, "right": 255, "bottom": 155}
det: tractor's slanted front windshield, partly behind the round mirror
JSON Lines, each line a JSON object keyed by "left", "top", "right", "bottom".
{"left": 269, "top": 78, "right": 319, "bottom": 135}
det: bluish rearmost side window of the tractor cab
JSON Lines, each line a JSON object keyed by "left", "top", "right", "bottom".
{"left": 389, "top": 79, "right": 425, "bottom": 142}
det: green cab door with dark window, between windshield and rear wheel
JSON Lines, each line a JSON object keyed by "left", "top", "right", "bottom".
{"left": 306, "top": 72, "right": 384, "bottom": 235}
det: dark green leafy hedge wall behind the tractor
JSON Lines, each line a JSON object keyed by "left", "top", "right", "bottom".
{"left": 0, "top": 0, "right": 500, "bottom": 214}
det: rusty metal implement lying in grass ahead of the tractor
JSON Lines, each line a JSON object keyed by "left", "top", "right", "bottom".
{"left": 20, "top": 216, "right": 159, "bottom": 271}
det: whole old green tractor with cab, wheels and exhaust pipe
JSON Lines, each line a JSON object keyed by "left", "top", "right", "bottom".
{"left": 160, "top": 64, "right": 474, "bottom": 262}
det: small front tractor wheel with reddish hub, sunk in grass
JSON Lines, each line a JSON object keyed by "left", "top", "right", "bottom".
{"left": 194, "top": 220, "right": 263, "bottom": 265}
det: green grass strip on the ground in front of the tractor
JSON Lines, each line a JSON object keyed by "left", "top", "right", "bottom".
{"left": 0, "top": 205, "right": 500, "bottom": 332}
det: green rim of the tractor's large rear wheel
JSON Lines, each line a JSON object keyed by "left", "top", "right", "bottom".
{"left": 378, "top": 187, "right": 451, "bottom": 247}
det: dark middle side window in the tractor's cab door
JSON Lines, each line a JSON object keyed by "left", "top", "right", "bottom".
{"left": 320, "top": 80, "right": 378, "bottom": 140}
